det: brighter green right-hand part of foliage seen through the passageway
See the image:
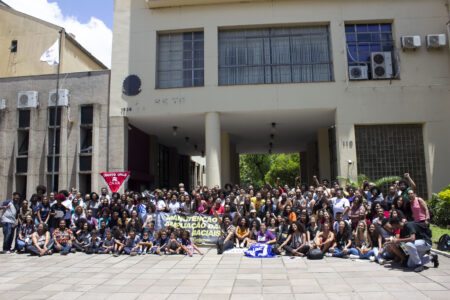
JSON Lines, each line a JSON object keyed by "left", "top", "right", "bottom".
{"left": 264, "top": 154, "right": 300, "bottom": 186}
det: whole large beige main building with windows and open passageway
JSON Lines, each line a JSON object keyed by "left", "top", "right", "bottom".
{"left": 109, "top": 0, "right": 450, "bottom": 197}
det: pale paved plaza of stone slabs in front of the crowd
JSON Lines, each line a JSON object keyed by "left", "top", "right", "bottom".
{"left": 0, "top": 245, "right": 450, "bottom": 300}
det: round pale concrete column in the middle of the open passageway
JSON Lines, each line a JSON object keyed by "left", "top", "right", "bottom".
{"left": 205, "top": 112, "right": 222, "bottom": 187}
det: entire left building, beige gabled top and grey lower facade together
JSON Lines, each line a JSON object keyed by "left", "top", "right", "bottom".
{"left": 0, "top": 1, "right": 110, "bottom": 199}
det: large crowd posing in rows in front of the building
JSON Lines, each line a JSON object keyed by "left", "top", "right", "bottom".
{"left": 0, "top": 174, "right": 439, "bottom": 272}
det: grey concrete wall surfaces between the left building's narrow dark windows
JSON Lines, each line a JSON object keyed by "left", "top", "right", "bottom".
{"left": 0, "top": 71, "right": 109, "bottom": 199}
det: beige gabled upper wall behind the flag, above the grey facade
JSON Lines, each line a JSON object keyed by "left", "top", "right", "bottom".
{"left": 0, "top": 7, "right": 104, "bottom": 77}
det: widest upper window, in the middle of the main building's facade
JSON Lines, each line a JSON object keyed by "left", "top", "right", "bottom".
{"left": 219, "top": 26, "right": 333, "bottom": 85}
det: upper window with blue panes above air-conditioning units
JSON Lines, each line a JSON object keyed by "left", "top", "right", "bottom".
{"left": 345, "top": 23, "right": 395, "bottom": 78}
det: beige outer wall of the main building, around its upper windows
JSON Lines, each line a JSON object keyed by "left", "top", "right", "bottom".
{"left": 111, "top": 0, "right": 450, "bottom": 195}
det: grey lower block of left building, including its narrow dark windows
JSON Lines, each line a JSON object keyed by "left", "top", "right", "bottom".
{"left": 0, "top": 70, "right": 110, "bottom": 199}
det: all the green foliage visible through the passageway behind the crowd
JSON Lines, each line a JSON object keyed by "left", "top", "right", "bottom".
{"left": 239, "top": 154, "right": 300, "bottom": 187}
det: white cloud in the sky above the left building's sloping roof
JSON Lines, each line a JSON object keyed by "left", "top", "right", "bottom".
{"left": 3, "top": 0, "right": 112, "bottom": 67}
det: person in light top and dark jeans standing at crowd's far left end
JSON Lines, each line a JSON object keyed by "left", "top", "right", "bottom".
{"left": 0, "top": 192, "right": 20, "bottom": 253}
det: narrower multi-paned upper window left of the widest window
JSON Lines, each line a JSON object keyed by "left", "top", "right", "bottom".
{"left": 157, "top": 32, "right": 204, "bottom": 88}
